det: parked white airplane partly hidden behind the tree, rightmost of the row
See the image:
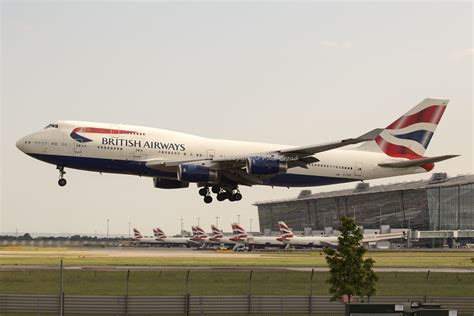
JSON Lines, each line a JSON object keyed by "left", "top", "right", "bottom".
{"left": 278, "top": 221, "right": 406, "bottom": 247}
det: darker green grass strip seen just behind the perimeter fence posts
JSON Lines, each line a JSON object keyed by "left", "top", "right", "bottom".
{"left": 0, "top": 270, "right": 474, "bottom": 296}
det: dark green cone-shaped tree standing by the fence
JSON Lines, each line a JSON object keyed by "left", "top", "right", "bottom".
{"left": 324, "top": 217, "right": 377, "bottom": 302}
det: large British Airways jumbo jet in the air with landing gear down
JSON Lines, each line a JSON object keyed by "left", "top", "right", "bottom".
{"left": 16, "top": 98, "right": 458, "bottom": 203}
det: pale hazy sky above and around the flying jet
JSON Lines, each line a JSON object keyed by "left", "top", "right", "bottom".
{"left": 0, "top": 1, "right": 474, "bottom": 235}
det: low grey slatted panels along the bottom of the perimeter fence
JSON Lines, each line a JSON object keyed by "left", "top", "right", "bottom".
{"left": 0, "top": 294, "right": 474, "bottom": 315}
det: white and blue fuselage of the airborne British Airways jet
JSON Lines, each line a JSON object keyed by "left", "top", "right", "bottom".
{"left": 17, "top": 121, "right": 425, "bottom": 187}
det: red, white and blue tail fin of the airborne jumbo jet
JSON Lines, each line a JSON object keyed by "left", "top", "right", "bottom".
{"left": 359, "top": 99, "right": 449, "bottom": 158}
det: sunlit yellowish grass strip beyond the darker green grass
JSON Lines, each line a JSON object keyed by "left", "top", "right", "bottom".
{"left": 0, "top": 248, "right": 474, "bottom": 272}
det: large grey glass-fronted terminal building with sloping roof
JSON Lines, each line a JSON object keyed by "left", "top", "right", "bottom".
{"left": 255, "top": 173, "right": 474, "bottom": 233}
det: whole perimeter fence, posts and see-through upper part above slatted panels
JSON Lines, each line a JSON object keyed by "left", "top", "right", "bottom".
{"left": 0, "top": 266, "right": 474, "bottom": 316}
